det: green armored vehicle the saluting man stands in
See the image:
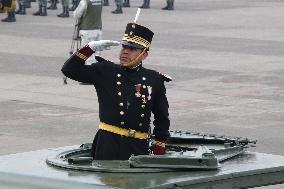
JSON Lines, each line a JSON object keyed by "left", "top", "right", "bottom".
{"left": 0, "top": 131, "right": 284, "bottom": 189}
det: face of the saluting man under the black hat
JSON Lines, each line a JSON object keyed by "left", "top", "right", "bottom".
{"left": 119, "top": 45, "right": 148, "bottom": 68}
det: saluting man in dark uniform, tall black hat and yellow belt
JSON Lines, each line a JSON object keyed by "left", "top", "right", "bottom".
{"left": 62, "top": 23, "right": 170, "bottom": 160}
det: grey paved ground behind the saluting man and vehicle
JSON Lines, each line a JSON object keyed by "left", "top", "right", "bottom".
{"left": 0, "top": 0, "right": 284, "bottom": 189}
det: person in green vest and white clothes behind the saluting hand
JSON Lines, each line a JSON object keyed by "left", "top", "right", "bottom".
{"left": 74, "top": 0, "right": 103, "bottom": 65}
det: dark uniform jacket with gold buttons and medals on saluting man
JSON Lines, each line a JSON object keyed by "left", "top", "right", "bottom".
{"left": 62, "top": 49, "right": 170, "bottom": 159}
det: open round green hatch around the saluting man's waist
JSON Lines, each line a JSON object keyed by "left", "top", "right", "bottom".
{"left": 46, "top": 131, "right": 256, "bottom": 173}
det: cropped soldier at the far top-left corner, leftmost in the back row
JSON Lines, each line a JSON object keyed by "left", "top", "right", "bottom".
{"left": 0, "top": 0, "right": 16, "bottom": 22}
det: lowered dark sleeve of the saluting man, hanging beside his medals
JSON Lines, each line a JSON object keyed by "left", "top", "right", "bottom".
{"left": 152, "top": 77, "right": 170, "bottom": 139}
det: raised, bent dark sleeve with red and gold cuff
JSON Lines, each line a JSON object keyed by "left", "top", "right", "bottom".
{"left": 61, "top": 46, "right": 105, "bottom": 84}
